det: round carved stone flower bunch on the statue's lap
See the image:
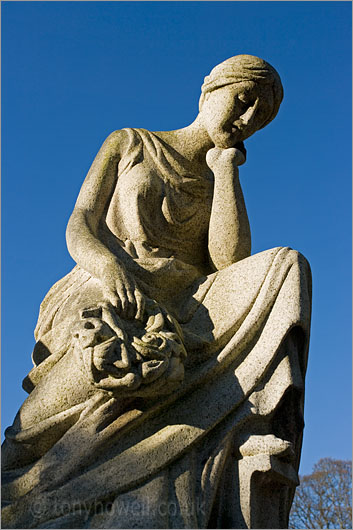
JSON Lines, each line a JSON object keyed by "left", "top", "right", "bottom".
{"left": 73, "top": 303, "right": 186, "bottom": 396}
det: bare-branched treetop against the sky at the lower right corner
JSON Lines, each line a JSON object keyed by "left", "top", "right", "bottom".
{"left": 289, "top": 458, "right": 352, "bottom": 528}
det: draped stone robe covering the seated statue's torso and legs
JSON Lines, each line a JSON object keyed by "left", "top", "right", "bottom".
{"left": 2, "top": 129, "right": 311, "bottom": 528}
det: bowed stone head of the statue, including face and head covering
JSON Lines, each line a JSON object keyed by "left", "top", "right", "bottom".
{"left": 199, "top": 55, "right": 283, "bottom": 148}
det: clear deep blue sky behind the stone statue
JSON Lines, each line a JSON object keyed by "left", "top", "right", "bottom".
{"left": 1, "top": 1, "right": 352, "bottom": 474}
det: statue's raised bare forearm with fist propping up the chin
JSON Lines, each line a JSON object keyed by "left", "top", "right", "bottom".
{"left": 206, "top": 147, "right": 251, "bottom": 270}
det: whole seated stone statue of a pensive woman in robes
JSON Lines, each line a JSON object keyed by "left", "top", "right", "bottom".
{"left": 2, "top": 55, "right": 311, "bottom": 528}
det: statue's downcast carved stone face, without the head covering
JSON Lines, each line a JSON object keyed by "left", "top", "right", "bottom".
{"left": 200, "top": 81, "right": 273, "bottom": 149}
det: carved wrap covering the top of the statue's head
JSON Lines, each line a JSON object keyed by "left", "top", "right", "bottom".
{"left": 199, "top": 55, "right": 283, "bottom": 128}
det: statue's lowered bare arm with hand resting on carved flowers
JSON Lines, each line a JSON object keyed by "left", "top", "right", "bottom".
{"left": 66, "top": 131, "right": 143, "bottom": 318}
